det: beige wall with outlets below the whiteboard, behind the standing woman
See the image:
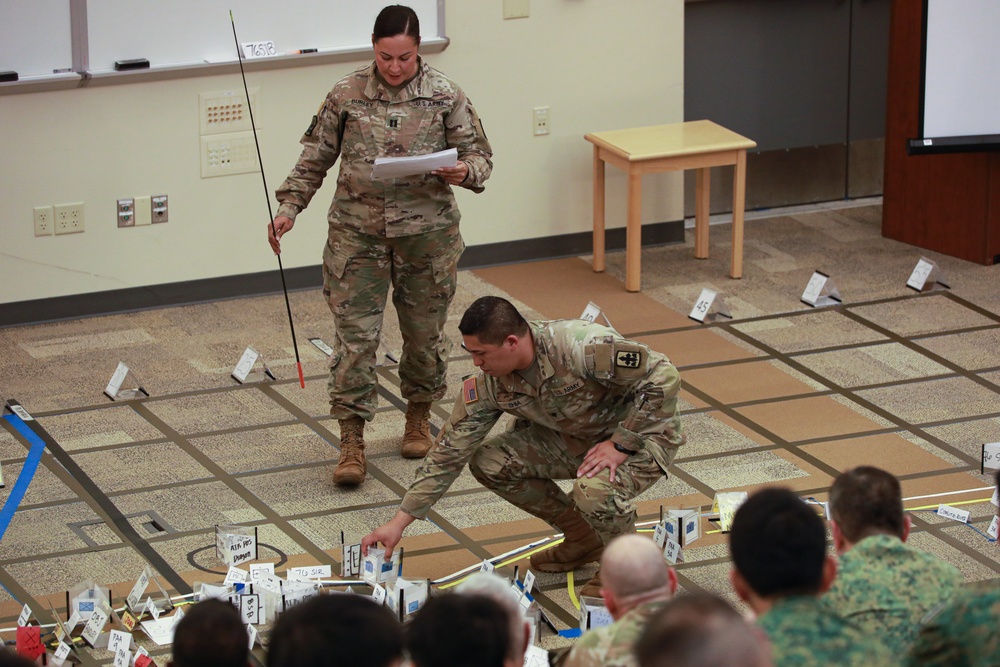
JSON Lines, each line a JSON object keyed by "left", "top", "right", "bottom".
{"left": 0, "top": 0, "right": 684, "bottom": 303}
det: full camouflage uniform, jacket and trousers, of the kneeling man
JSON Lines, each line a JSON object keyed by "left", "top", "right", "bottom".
{"left": 400, "top": 320, "right": 684, "bottom": 543}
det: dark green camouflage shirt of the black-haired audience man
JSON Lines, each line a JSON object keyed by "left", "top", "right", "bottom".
{"left": 757, "top": 596, "right": 901, "bottom": 667}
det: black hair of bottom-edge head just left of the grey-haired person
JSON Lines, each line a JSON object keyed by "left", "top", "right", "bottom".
{"left": 406, "top": 593, "right": 510, "bottom": 667}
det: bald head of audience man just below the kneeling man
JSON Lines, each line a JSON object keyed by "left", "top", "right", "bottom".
{"left": 601, "top": 533, "right": 677, "bottom": 619}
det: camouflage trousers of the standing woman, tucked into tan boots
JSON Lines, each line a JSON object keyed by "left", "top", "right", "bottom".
{"left": 323, "top": 225, "right": 465, "bottom": 421}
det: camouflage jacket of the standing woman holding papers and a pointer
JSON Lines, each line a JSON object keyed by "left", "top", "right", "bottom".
{"left": 275, "top": 59, "right": 493, "bottom": 238}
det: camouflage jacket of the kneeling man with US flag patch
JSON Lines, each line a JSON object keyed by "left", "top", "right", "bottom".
{"left": 401, "top": 320, "right": 684, "bottom": 519}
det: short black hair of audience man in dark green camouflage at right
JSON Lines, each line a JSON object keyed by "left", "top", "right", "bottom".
{"left": 729, "top": 487, "right": 826, "bottom": 597}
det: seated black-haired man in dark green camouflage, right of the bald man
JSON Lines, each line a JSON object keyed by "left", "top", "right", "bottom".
{"left": 729, "top": 488, "right": 900, "bottom": 667}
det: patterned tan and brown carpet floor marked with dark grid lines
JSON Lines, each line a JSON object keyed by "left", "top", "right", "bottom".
{"left": 0, "top": 203, "right": 1000, "bottom": 665}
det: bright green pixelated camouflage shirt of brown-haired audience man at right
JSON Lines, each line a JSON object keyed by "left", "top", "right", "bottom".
{"left": 823, "top": 535, "right": 963, "bottom": 655}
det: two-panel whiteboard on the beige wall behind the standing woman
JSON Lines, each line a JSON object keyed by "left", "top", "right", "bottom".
{"left": 0, "top": 0, "right": 444, "bottom": 78}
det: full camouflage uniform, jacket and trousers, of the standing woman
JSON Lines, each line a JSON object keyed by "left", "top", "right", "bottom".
{"left": 276, "top": 59, "right": 493, "bottom": 420}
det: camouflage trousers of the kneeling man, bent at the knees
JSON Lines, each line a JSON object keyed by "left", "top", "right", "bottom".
{"left": 469, "top": 422, "right": 672, "bottom": 544}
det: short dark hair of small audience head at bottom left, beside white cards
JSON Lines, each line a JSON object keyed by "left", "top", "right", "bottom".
{"left": 173, "top": 599, "right": 250, "bottom": 667}
